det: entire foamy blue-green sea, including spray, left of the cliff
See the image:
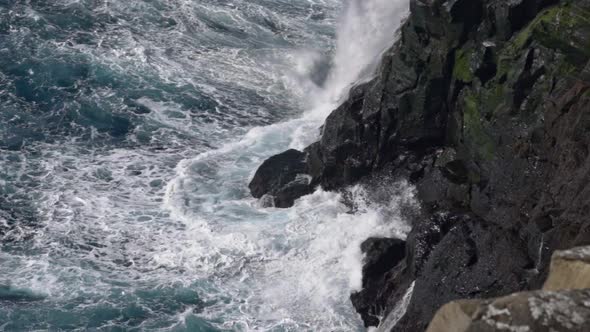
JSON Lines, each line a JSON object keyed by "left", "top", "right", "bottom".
{"left": 0, "top": 0, "right": 415, "bottom": 331}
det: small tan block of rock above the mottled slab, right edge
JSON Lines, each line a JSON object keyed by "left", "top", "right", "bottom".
{"left": 543, "top": 247, "right": 590, "bottom": 291}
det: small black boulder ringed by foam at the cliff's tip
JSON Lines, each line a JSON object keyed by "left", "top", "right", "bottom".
{"left": 249, "top": 149, "right": 312, "bottom": 208}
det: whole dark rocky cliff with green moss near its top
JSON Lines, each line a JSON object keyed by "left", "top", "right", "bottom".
{"left": 251, "top": 0, "right": 590, "bottom": 331}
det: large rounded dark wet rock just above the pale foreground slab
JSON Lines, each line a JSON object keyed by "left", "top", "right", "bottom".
{"left": 396, "top": 215, "right": 533, "bottom": 331}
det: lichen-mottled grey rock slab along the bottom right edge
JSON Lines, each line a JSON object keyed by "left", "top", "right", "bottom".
{"left": 427, "top": 289, "right": 590, "bottom": 332}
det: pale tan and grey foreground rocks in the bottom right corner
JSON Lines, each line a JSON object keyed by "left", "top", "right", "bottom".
{"left": 427, "top": 247, "right": 590, "bottom": 332}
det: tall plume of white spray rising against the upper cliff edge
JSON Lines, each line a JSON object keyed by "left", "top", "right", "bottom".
{"left": 290, "top": 0, "right": 409, "bottom": 149}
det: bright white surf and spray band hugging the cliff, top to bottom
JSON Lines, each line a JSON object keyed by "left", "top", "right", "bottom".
{"left": 165, "top": 1, "right": 413, "bottom": 331}
